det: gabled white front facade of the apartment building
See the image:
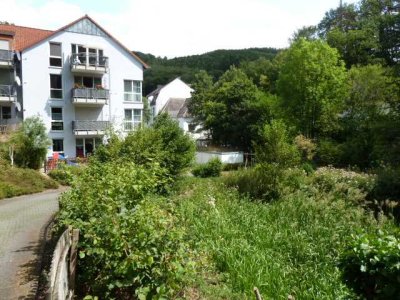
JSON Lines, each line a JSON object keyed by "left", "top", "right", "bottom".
{"left": 21, "top": 17, "right": 144, "bottom": 157}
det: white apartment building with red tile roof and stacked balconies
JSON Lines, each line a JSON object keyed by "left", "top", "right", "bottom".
{"left": 0, "top": 15, "right": 147, "bottom": 157}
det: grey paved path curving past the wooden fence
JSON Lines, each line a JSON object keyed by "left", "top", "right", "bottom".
{"left": 0, "top": 190, "right": 62, "bottom": 300}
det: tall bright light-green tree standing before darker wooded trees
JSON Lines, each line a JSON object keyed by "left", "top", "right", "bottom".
{"left": 278, "top": 39, "right": 346, "bottom": 138}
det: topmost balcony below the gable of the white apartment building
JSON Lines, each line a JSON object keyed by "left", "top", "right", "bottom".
{"left": 70, "top": 53, "right": 108, "bottom": 74}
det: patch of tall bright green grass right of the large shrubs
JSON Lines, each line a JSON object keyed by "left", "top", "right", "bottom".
{"left": 176, "top": 179, "right": 392, "bottom": 299}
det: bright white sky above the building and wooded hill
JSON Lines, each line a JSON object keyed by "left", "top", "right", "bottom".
{"left": 0, "top": 0, "right": 356, "bottom": 58}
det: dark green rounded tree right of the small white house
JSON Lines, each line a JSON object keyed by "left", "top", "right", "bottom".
{"left": 190, "top": 67, "right": 270, "bottom": 150}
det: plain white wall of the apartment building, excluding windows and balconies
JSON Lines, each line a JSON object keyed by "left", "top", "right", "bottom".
{"left": 22, "top": 31, "right": 143, "bottom": 157}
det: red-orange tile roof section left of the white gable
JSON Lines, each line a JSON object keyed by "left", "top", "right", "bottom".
{"left": 0, "top": 24, "right": 54, "bottom": 51}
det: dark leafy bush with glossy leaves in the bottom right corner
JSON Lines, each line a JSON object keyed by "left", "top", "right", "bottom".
{"left": 340, "top": 231, "right": 400, "bottom": 299}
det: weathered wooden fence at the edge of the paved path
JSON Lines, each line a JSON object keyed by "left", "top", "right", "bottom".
{"left": 47, "top": 227, "right": 79, "bottom": 300}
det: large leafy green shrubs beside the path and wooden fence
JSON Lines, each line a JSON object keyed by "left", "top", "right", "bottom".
{"left": 57, "top": 115, "right": 194, "bottom": 299}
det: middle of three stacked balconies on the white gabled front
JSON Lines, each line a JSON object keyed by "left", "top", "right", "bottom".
{"left": 72, "top": 88, "right": 110, "bottom": 106}
